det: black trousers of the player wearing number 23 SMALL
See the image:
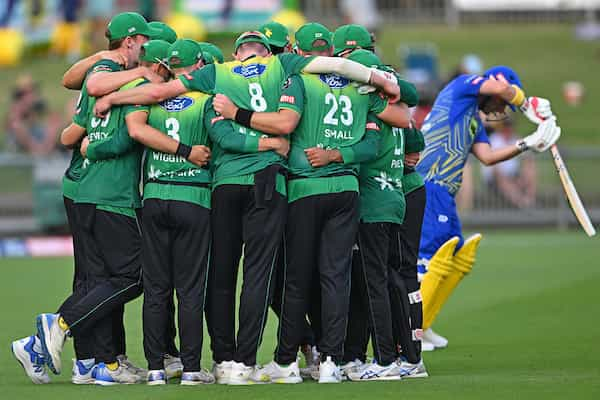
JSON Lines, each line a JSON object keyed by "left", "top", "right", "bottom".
{"left": 275, "top": 192, "right": 358, "bottom": 364}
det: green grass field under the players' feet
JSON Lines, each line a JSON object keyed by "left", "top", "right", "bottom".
{"left": 0, "top": 231, "right": 600, "bottom": 400}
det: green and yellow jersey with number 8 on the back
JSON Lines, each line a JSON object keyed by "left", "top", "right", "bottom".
{"left": 179, "top": 53, "right": 313, "bottom": 191}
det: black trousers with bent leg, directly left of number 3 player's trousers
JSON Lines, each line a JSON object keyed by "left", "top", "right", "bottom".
{"left": 61, "top": 204, "right": 141, "bottom": 363}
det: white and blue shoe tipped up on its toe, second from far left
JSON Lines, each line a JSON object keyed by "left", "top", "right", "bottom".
{"left": 35, "top": 314, "right": 67, "bottom": 375}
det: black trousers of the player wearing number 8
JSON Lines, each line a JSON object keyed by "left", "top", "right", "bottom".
{"left": 206, "top": 185, "right": 287, "bottom": 366}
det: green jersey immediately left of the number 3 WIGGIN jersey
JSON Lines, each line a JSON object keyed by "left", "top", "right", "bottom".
{"left": 76, "top": 79, "right": 143, "bottom": 211}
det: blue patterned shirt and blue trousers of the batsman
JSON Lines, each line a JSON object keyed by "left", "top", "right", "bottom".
{"left": 417, "top": 75, "right": 489, "bottom": 273}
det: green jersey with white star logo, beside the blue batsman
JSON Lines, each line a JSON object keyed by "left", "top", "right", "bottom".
{"left": 359, "top": 124, "right": 406, "bottom": 224}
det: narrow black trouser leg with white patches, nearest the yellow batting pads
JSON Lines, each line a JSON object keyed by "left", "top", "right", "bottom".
{"left": 393, "top": 186, "right": 426, "bottom": 363}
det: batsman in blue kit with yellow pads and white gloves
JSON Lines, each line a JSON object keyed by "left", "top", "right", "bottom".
{"left": 417, "top": 66, "right": 560, "bottom": 347}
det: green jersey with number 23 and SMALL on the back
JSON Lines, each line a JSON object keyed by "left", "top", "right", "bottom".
{"left": 279, "top": 74, "right": 387, "bottom": 201}
